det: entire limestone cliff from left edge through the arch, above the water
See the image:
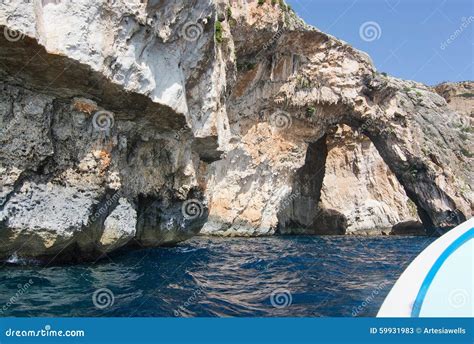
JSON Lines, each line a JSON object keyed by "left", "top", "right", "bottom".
{"left": 0, "top": 0, "right": 472, "bottom": 259}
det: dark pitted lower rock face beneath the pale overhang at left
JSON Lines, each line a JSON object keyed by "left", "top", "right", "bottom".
{"left": 0, "top": 80, "right": 205, "bottom": 259}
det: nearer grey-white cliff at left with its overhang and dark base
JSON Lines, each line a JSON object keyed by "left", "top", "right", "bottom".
{"left": 0, "top": 1, "right": 213, "bottom": 259}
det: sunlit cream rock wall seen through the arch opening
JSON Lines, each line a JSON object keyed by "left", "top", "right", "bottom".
{"left": 320, "top": 126, "right": 422, "bottom": 234}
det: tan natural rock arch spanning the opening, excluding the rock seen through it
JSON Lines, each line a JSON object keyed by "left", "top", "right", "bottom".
{"left": 204, "top": 16, "right": 472, "bottom": 235}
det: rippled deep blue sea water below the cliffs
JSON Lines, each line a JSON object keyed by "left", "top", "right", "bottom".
{"left": 0, "top": 236, "right": 434, "bottom": 317}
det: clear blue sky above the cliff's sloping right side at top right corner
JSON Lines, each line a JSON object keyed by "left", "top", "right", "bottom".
{"left": 287, "top": 0, "right": 474, "bottom": 85}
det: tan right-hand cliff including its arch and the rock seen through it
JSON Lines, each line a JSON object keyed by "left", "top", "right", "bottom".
{"left": 199, "top": 2, "right": 473, "bottom": 235}
